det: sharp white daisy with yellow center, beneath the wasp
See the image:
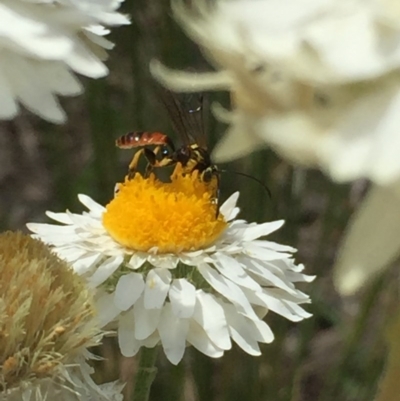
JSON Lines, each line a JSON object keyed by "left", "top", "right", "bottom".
{"left": 28, "top": 165, "right": 313, "bottom": 364}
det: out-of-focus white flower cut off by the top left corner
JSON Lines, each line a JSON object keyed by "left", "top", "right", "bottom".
{"left": 0, "top": 0, "right": 129, "bottom": 123}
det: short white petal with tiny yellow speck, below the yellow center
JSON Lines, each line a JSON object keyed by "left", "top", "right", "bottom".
{"left": 144, "top": 268, "right": 171, "bottom": 309}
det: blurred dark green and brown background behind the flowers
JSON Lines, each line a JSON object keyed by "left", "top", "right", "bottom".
{"left": 0, "top": 0, "right": 398, "bottom": 401}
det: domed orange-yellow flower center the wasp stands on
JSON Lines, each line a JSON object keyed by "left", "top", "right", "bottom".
{"left": 103, "top": 164, "right": 227, "bottom": 253}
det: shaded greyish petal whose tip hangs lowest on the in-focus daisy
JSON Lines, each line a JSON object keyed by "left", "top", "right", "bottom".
{"left": 158, "top": 303, "right": 189, "bottom": 365}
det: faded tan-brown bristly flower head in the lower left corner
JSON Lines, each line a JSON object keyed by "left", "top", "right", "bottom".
{"left": 0, "top": 232, "right": 122, "bottom": 401}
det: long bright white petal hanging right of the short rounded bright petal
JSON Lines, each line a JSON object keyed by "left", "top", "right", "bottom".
{"left": 193, "top": 290, "right": 232, "bottom": 350}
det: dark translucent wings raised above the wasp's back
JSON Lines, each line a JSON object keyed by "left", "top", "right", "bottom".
{"left": 159, "top": 88, "right": 206, "bottom": 148}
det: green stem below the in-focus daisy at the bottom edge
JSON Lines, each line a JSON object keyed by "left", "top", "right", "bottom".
{"left": 133, "top": 347, "right": 158, "bottom": 401}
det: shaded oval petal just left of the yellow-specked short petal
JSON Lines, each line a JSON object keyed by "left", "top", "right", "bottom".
{"left": 114, "top": 273, "right": 144, "bottom": 311}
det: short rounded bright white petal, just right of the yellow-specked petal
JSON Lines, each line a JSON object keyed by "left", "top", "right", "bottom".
{"left": 168, "top": 278, "right": 196, "bottom": 318}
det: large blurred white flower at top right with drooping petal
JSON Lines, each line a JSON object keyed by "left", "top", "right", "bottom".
{"left": 152, "top": 0, "right": 400, "bottom": 294}
